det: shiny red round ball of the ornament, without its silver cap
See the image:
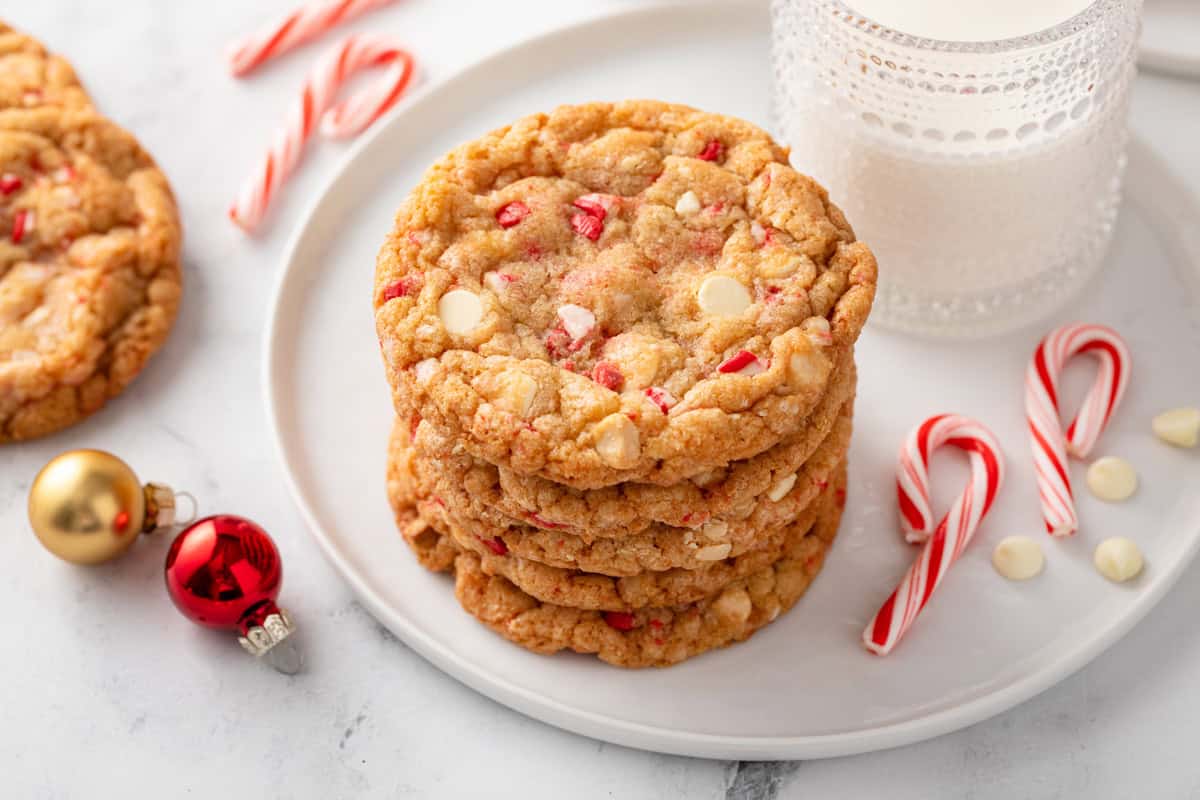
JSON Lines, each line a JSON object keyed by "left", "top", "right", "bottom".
{"left": 167, "top": 515, "right": 283, "bottom": 636}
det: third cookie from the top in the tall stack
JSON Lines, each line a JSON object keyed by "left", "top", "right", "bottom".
{"left": 389, "top": 407, "right": 852, "bottom": 575}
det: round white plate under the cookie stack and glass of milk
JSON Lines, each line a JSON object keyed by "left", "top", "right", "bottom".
{"left": 265, "top": 2, "right": 1200, "bottom": 758}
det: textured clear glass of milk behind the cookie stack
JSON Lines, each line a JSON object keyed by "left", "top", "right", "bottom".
{"left": 772, "top": 0, "right": 1142, "bottom": 336}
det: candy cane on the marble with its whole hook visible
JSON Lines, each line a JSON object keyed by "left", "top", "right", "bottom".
{"left": 229, "top": 36, "right": 413, "bottom": 231}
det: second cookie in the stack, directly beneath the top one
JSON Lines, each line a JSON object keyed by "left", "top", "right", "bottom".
{"left": 419, "top": 360, "right": 857, "bottom": 537}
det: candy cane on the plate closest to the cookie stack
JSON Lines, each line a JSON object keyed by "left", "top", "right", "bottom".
{"left": 863, "top": 414, "right": 1004, "bottom": 656}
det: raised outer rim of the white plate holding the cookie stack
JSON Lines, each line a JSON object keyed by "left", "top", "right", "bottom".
{"left": 262, "top": 0, "right": 1200, "bottom": 759}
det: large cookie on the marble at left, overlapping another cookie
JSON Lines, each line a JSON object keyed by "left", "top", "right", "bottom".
{"left": 0, "top": 107, "right": 181, "bottom": 443}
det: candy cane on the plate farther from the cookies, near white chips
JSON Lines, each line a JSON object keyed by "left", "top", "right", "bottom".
{"left": 1025, "top": 325, "right": 1129, "bottom": 536}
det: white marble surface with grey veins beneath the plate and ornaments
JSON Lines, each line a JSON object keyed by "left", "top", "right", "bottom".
{"left": 0, "top": 0, "right": 1200, "bottom": 799}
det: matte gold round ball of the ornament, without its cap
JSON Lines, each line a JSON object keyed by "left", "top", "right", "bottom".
{"left": 29, "top": 450, "right": 146, "bottom": 564}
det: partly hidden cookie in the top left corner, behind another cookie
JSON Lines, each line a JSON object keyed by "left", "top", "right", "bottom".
{"left": 0, "top": 22, "right": 91, "bottom": 110}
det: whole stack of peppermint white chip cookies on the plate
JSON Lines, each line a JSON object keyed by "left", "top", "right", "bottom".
{"left": 374, "top": 101, "right": 876, "bottom": 667}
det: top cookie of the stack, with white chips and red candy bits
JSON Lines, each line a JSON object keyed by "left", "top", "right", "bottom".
{"left": 374, "top": 101, "right": 876, "bottom": 488}
